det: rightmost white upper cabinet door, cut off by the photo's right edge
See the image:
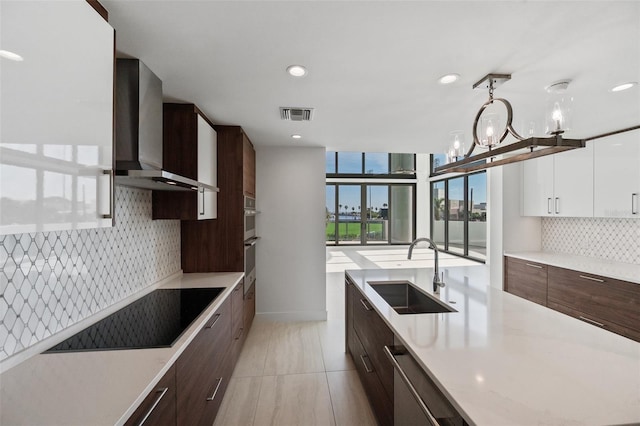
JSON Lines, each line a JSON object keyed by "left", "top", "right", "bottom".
{"left": 593, "top": 131, "right": 640, "bottom": 218}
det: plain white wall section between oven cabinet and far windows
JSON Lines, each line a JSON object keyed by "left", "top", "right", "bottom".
{"left": 256, "top": 146, "right": 327, "bottom": 321}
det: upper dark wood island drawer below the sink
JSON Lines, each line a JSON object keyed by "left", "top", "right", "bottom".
{"left": 353, "top": 286, "right": 393, "bottom": 397}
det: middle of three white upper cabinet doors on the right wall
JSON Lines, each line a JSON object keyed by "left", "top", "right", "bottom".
{"left": 550, "top": 142, "right": 593, "bottom": 217}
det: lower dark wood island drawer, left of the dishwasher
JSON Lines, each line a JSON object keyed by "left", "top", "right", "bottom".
{"left": 351, "top": 324, "right": 393, "bottom": 426}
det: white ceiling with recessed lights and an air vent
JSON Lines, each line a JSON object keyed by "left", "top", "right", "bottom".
{"left": 102, "top": 0, "right": 640, "bottom": 152}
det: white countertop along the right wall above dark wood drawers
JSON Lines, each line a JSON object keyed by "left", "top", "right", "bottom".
{"left": 504, "top": 251, "right": 640, "bottom": 284}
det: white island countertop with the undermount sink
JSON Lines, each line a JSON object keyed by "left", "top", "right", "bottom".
{"left": 347, "top": 265, "right": 640, "bottom": 426}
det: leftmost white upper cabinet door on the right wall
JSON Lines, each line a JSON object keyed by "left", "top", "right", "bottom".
{"left": 522, "top": 155, "right": 553, "bottom": 216}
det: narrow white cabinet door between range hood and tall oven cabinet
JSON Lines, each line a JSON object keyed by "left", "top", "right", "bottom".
{"left": 198, "top": 115, "right": 218, "bottom": 219}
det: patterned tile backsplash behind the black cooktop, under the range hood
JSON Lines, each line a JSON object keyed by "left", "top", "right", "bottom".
{"left": 0, "top": 186, "right": 180, "bottom": 361}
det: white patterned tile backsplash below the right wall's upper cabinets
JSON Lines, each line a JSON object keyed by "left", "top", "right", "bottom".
{"left": 542, "top": 218, "right": 640, "bottom": 264}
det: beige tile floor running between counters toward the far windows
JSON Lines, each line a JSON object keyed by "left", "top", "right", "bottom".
{"left": 215, "top": 246, "right": 468, "bottom": 426}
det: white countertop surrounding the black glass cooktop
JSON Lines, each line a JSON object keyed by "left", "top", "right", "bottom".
{"left": 0, "top": 272, "right": 244, "bottom": 425}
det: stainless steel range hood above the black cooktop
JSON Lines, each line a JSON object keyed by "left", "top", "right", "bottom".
{"left": 116, "top": 59, "right": 217, "bottom": 191}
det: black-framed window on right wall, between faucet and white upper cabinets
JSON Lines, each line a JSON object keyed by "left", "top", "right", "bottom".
{"left": 431, "top": 156, "right": 487, "bottom": 261}
